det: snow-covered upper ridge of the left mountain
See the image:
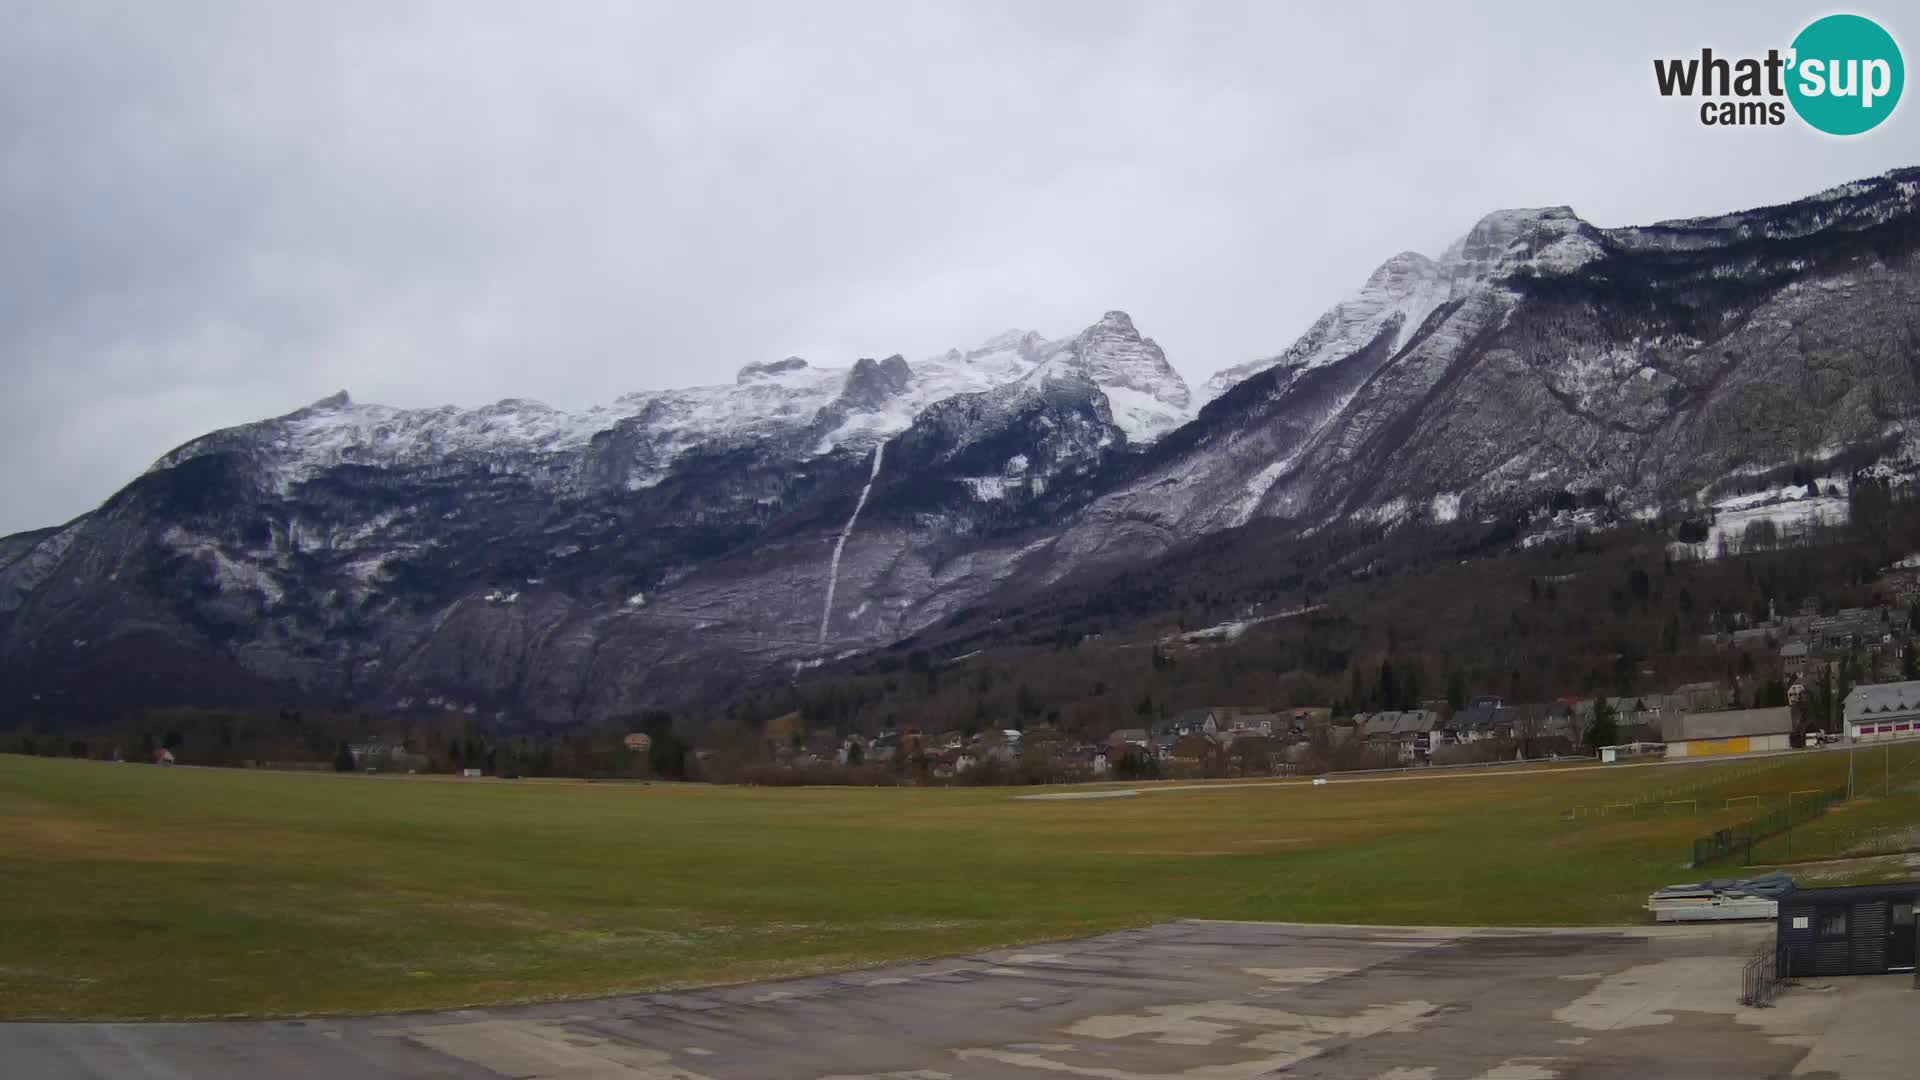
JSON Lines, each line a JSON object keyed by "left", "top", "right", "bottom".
{"left": 154, "top": 311, "right": 1190, "bottom": 490}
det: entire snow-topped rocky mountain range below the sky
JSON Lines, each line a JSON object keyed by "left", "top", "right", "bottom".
{"left": 0, "top": 171, "right": 1920, "bottom": 724}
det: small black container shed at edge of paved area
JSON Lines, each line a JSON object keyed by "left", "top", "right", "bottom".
{"left": 1776, "top": 882, "right": 1920, "bottom": 976}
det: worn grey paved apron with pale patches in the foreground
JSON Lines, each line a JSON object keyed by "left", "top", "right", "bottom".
{"left": 0, "top": 922, "right": 1920, "bottom": 1080}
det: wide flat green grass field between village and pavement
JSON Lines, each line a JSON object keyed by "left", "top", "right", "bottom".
{"left": 0, "top": 753, "right": 1904, "bottom": 1019}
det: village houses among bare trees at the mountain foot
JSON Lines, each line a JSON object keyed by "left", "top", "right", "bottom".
{"left": 749, "top": 557, "right": 1920, "bottom": 784}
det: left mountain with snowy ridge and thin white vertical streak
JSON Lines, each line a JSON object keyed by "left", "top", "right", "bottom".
{"left": 0, "top": 311, "right": 1188, "bottom": 724}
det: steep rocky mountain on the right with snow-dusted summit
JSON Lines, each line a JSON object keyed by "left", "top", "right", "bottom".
{"left": 1058, "top": 169, "right": 1920, "bottom": 561}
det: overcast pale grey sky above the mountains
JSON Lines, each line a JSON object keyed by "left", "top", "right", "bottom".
{"left": 0, "top": 0, "right": 1920, "bottom": 532}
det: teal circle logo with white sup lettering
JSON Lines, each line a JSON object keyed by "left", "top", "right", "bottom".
{"left": 1788, "top": 15, "right": 1907, "bottom": 135}
